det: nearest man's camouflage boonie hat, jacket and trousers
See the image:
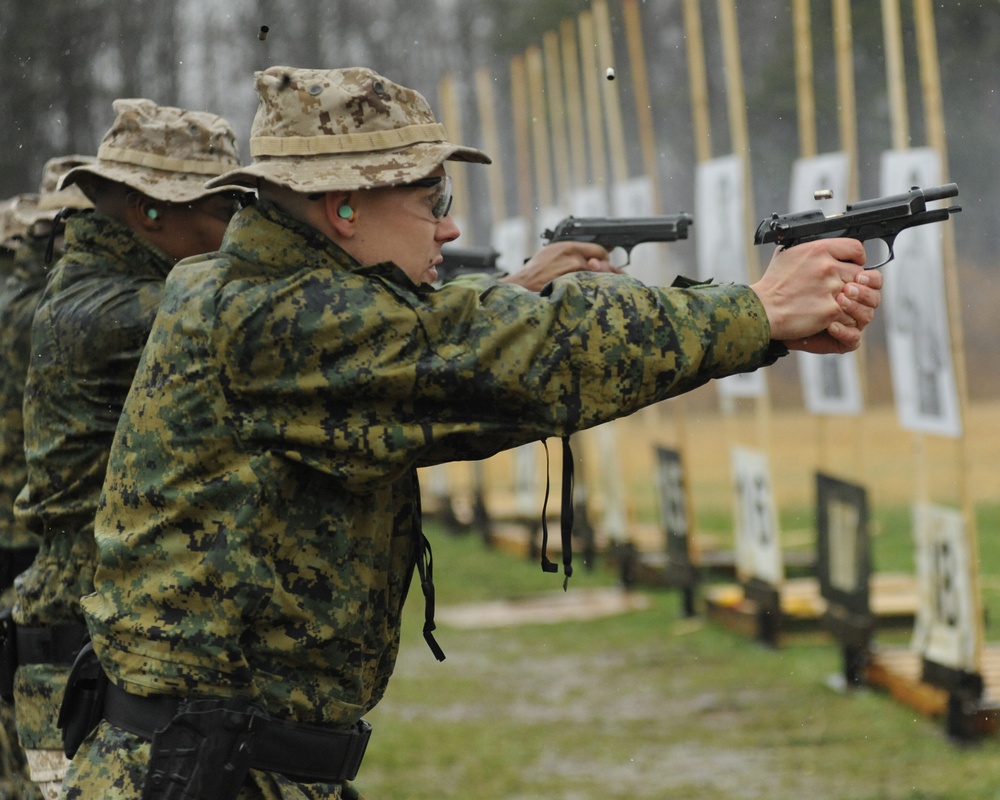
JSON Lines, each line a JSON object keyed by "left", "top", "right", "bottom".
{"left": 60, "top": 67, "right": 876, "bottom": 800}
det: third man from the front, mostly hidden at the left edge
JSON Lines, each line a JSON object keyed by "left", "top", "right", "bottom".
{"left": 0, "top": 162, "right": 91, "bottom": 798}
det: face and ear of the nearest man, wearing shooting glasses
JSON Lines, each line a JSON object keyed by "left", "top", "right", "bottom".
{"left": 350, "top": 167, "right": 459, "bottom": 283}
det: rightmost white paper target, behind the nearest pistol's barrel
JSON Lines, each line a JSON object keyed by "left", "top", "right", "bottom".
{"left": 880, "top": 147, "right": 962, "bottom": 437}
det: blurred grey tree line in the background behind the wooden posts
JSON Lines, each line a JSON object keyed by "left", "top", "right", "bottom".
{"left": 0, "top": 0, "right": 1000, "bottom": 394}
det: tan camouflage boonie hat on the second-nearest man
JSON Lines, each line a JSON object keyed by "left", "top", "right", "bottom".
{"left": 60, "top": 98, "right": 244, "bottom": 203}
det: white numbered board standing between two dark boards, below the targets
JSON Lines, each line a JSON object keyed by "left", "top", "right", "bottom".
{"left": 731, "top": 447, "right": 784, "bottom": 588}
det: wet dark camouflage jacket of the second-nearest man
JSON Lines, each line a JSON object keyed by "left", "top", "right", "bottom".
{"left": 14, "top": 213, "right": 172, "bottom": 626}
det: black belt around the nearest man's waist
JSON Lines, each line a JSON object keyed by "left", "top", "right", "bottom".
{"left": 104, "top": 682, "right": 372, "bottom": 783}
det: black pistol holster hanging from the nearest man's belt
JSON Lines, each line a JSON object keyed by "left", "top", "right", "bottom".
{"left": 142, "top": 698, "right": 256, "bottom": 800}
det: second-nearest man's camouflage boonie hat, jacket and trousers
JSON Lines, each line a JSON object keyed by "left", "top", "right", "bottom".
{"left": 8, "top": 99, "right": 239, "bottom": 797}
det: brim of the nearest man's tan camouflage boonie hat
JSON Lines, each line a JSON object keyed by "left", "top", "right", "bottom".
{"left": 206, "top": 142, "right": 493, "bottom": 193}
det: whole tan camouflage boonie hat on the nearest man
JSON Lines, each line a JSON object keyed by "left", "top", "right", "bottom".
{"left": 209, "top": 67, "right": 490, "bottom": 192}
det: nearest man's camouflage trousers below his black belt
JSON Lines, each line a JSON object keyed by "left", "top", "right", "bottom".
{"left": 63, "top": 721, "right": 363, "bottom": 800}
